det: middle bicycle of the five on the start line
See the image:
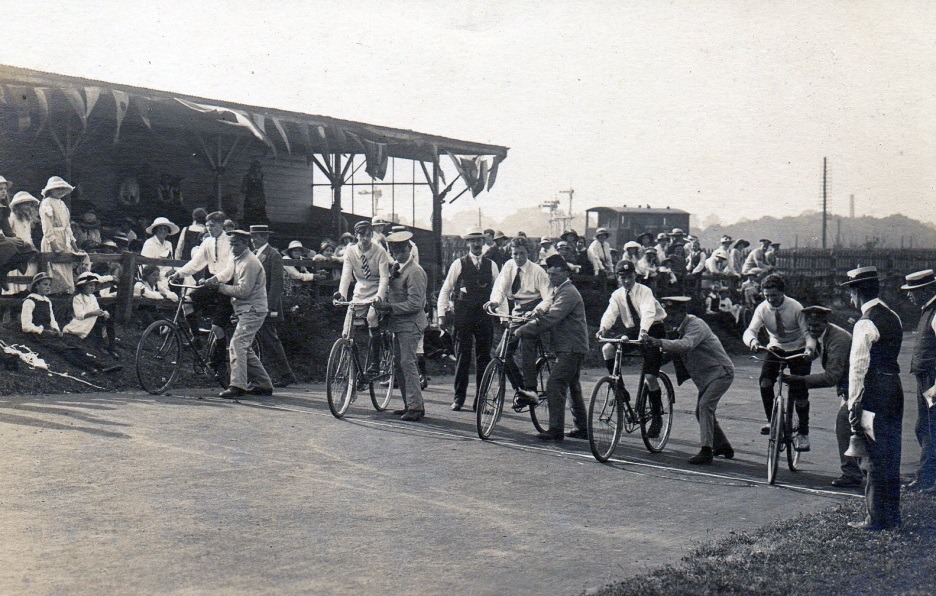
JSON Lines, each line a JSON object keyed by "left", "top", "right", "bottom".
{"left": 474, "top": 310, "right": 551, "bottom": 439}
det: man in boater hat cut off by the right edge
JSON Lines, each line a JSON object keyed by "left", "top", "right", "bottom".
{"left": 900, "top": 269, "right": 936, "bottom": 492}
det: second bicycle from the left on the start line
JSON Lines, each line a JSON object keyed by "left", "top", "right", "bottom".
{"left": 325, "top": 300, "right": 396, "bottom": 418}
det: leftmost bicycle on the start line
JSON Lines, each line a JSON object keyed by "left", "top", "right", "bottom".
{"left": 136, "top": 284, "right": 247, "bottom": 395}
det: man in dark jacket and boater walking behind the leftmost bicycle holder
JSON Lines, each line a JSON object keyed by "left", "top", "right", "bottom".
{"left": 250, "top": 225, "right": 296, "bottom": 387}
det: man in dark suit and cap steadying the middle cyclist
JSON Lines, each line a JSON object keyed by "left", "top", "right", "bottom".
{"left": 516, "top": 255, "right": 588, "bottom": 441}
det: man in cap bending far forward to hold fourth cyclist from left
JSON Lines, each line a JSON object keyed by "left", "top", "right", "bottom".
{"left": 644, "top": 296, "right": 734, "bottom": 465}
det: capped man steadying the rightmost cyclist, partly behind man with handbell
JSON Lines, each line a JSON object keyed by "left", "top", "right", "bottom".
{"left": 783, "top": 305, "right": 864, "bottom": 488}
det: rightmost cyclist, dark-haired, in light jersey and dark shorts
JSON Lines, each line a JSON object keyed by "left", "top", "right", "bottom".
{"left": 743, "top": 273, "right": 815, "bottom": 451}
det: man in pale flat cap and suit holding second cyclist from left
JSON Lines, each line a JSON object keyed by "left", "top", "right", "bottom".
{"left": 374, "top": 232, "right": 429, "bottom": 422}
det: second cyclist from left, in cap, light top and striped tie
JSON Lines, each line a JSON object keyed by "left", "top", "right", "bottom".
{"left": 334, "top": 220, "right": 390, "bottom": 374}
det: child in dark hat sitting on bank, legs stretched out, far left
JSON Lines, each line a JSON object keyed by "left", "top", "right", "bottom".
{"left": 20, "top": 271, "right": 122, "bottom": 374}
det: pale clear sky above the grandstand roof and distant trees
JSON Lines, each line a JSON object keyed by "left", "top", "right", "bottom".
{"left": 0, "top": 0, "right": 936, "bottom": 223}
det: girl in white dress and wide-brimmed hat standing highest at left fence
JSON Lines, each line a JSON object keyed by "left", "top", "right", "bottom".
{"left": 39, "top": 176, "right": 91, "bottom": 294}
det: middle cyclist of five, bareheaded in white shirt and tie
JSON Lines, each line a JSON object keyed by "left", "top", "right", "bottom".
{"left": 484, "top": 238, "right": 551, "bottom": 406}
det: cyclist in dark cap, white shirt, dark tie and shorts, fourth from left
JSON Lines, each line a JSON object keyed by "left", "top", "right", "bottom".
{"left": 598, "top": 260, "right": 666, "bottom": 438}
